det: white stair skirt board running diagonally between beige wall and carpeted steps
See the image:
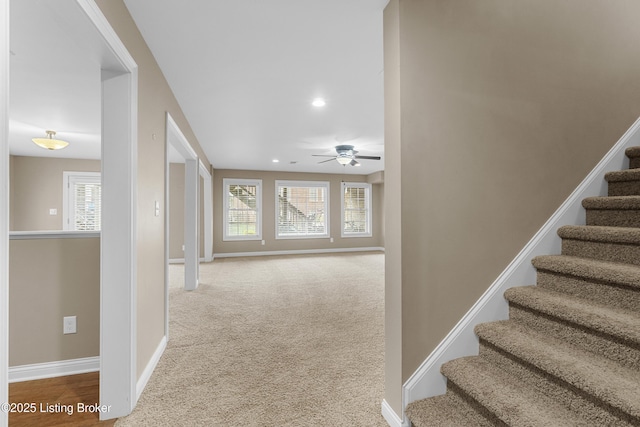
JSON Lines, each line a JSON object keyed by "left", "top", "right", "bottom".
{"left": 402, "top": 119, "right": 640, "bottom": 409}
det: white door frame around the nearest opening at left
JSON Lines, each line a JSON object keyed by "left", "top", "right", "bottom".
{"left": 0, "top": 0, "right": 138, "bottom": 426}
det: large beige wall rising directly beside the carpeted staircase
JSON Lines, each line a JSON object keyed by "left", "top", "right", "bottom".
{"left": 385, "top": 0, "right": 640, "bottom": 410}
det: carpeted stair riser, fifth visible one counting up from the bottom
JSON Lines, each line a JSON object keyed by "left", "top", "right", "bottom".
{"left": 562, "top": 238, "right": 640, "bottom": 265}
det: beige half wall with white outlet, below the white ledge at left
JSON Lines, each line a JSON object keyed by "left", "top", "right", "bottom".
{"left": 9, "top": 237, "right": 100, "bottom": 366}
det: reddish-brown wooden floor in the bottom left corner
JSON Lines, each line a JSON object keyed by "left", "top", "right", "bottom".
{"left": 9, "top": 372, "right": 115, "bottom": 427}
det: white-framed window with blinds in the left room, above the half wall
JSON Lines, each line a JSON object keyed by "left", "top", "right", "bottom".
{"left": 62, "top": 172, "right": 102, "bottom": 231}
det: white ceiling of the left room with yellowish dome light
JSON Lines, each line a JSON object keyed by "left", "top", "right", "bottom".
{"left": 9, "top": 0, "right": 102, "bottom": 159}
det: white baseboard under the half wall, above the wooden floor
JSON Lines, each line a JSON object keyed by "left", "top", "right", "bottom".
{"left": 9, "top": 357, "right": 100, "bottom": 383}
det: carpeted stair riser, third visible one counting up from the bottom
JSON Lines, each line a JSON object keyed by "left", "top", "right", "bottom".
{"left": 509, "top": 304, "right": 640, "bottom": 369}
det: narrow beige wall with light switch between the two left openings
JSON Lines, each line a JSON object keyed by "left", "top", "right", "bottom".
{"left": 96, "top": 0, "right": 210, "bottom": 382}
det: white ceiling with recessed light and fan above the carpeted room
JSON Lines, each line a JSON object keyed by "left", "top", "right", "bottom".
{"left": 124, "top": 0, "right": 388, "bottom": 174}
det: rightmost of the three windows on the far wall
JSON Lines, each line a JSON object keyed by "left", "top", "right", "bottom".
{"left": 341, "top": 182, "right": 371, "bottom": 237}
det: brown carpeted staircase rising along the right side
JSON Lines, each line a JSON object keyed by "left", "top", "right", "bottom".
{"left": 406, "top": 147, "right": 640, "bottom": 427}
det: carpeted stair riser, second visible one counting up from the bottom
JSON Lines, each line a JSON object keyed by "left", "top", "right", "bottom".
{"left": 480, "top": 340, "right": 638, "bottom": 426}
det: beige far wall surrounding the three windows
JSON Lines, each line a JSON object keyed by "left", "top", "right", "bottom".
{"left": 213, "top": 170, "right": 384, "bottom": 254}
